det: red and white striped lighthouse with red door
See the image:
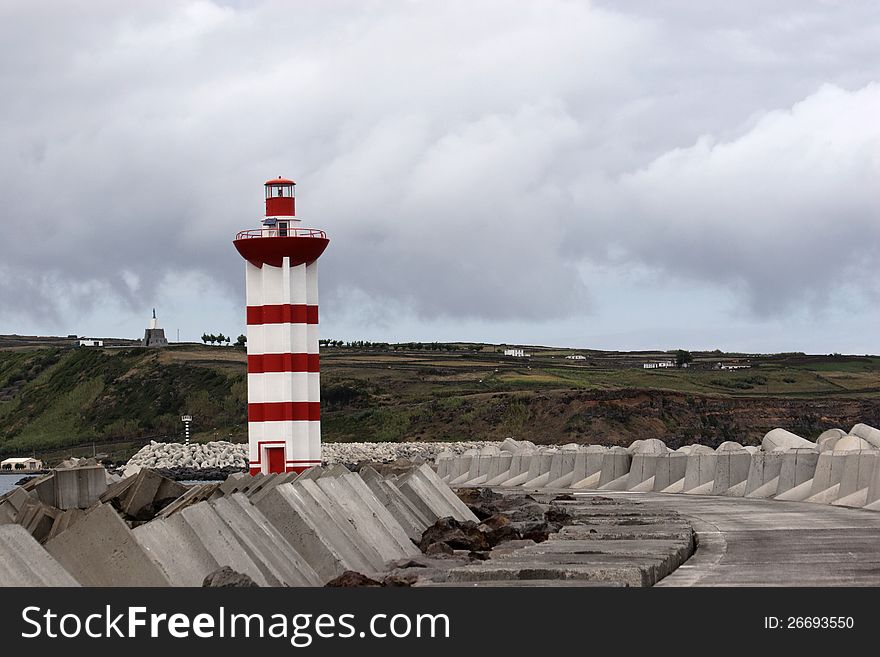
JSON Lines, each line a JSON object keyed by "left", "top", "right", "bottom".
{"left": 233, "top": 177, "right": 329, "bottom": 474}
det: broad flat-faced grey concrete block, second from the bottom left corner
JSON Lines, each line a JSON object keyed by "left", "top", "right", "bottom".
{"left": 46, "top": 504, "right": 171, "bottom": 586}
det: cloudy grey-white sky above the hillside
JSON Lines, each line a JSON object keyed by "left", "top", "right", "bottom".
{"left": 0, "top": 0, "right": 880, "bottom": 353}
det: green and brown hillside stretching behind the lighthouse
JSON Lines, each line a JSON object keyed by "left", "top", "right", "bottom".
{"left": 0, "top": 344, "right": 880, "bottom": 462}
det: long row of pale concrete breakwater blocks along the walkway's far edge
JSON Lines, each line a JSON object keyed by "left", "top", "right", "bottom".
{"left": 436, "top": 424, "right": 880, "bottom": 510}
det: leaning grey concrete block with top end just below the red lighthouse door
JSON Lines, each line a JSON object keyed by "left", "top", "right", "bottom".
{"left": 255, "top": 484, "right": 350, "bottom": 582}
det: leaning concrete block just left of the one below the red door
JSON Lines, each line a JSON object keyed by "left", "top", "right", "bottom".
{"left": 210, "top": 493, "right": 321, "bottom": 586}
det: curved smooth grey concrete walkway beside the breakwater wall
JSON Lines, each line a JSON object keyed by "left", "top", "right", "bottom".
{"left": 576, "top": 491, "right": 880, "bottom": 586}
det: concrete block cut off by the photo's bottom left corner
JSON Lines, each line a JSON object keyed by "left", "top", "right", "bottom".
{"left": 0, "top": 524, "right": 79, "bottom": 587}
